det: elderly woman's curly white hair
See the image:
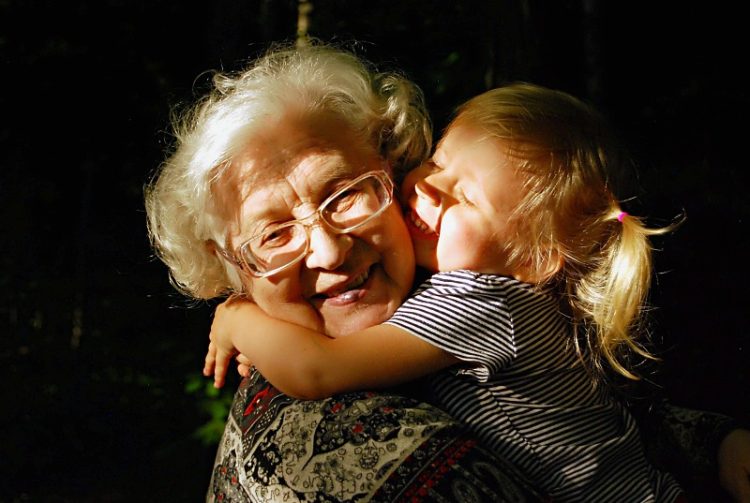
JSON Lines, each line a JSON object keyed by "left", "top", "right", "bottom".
{"left": 145, "top": 41, "right": 432, "bottom": 299}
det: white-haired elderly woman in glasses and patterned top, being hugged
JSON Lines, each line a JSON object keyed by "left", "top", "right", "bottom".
{"left": 146, "top": 41, "right": 750, "bottom": 501}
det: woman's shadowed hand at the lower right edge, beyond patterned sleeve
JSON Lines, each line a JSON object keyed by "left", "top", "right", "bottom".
{"left": 719, "top": 429, "right": 750, "bottom": 503}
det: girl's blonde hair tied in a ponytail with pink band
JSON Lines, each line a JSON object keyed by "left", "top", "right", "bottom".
{"left": 448, "top": 83, "right": 676, "bottom": 379}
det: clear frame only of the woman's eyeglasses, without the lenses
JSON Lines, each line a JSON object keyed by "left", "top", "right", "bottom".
{"left": 217, "top": 170, "right": 393, "bottom": 278}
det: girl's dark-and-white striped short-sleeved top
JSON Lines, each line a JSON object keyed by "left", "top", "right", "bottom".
{"left": 387, "top": 271, "right": 681, "bottom": 502}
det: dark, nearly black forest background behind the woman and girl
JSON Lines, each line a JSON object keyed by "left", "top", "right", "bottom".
{"left": 0, "top": 0, "right": 750, "bottom": 502}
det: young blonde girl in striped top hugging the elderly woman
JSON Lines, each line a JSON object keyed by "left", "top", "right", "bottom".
{"left": 204, "top": 84, "right": 681, "bottom": 501}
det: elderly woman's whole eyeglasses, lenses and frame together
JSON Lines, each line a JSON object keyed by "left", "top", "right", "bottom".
{"left": 219, "top": 170, "right": 393, "bottom": 278}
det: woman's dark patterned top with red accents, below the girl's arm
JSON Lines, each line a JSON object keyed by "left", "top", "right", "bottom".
{"left": 207, "top": 372, "right": 545, "bottom": 502}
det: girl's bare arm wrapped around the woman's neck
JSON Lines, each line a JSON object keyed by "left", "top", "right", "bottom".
{"left": 204, "top": 300, "right": 458, "bottom": 399}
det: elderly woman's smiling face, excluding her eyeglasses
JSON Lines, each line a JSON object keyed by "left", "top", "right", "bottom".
{"left": 230, "top": 116, "right": 414, "bottom": 337}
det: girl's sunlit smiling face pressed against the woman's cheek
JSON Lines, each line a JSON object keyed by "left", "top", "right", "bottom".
{"left": 402, "top": 124, "right": 523, "bottom": 276}
